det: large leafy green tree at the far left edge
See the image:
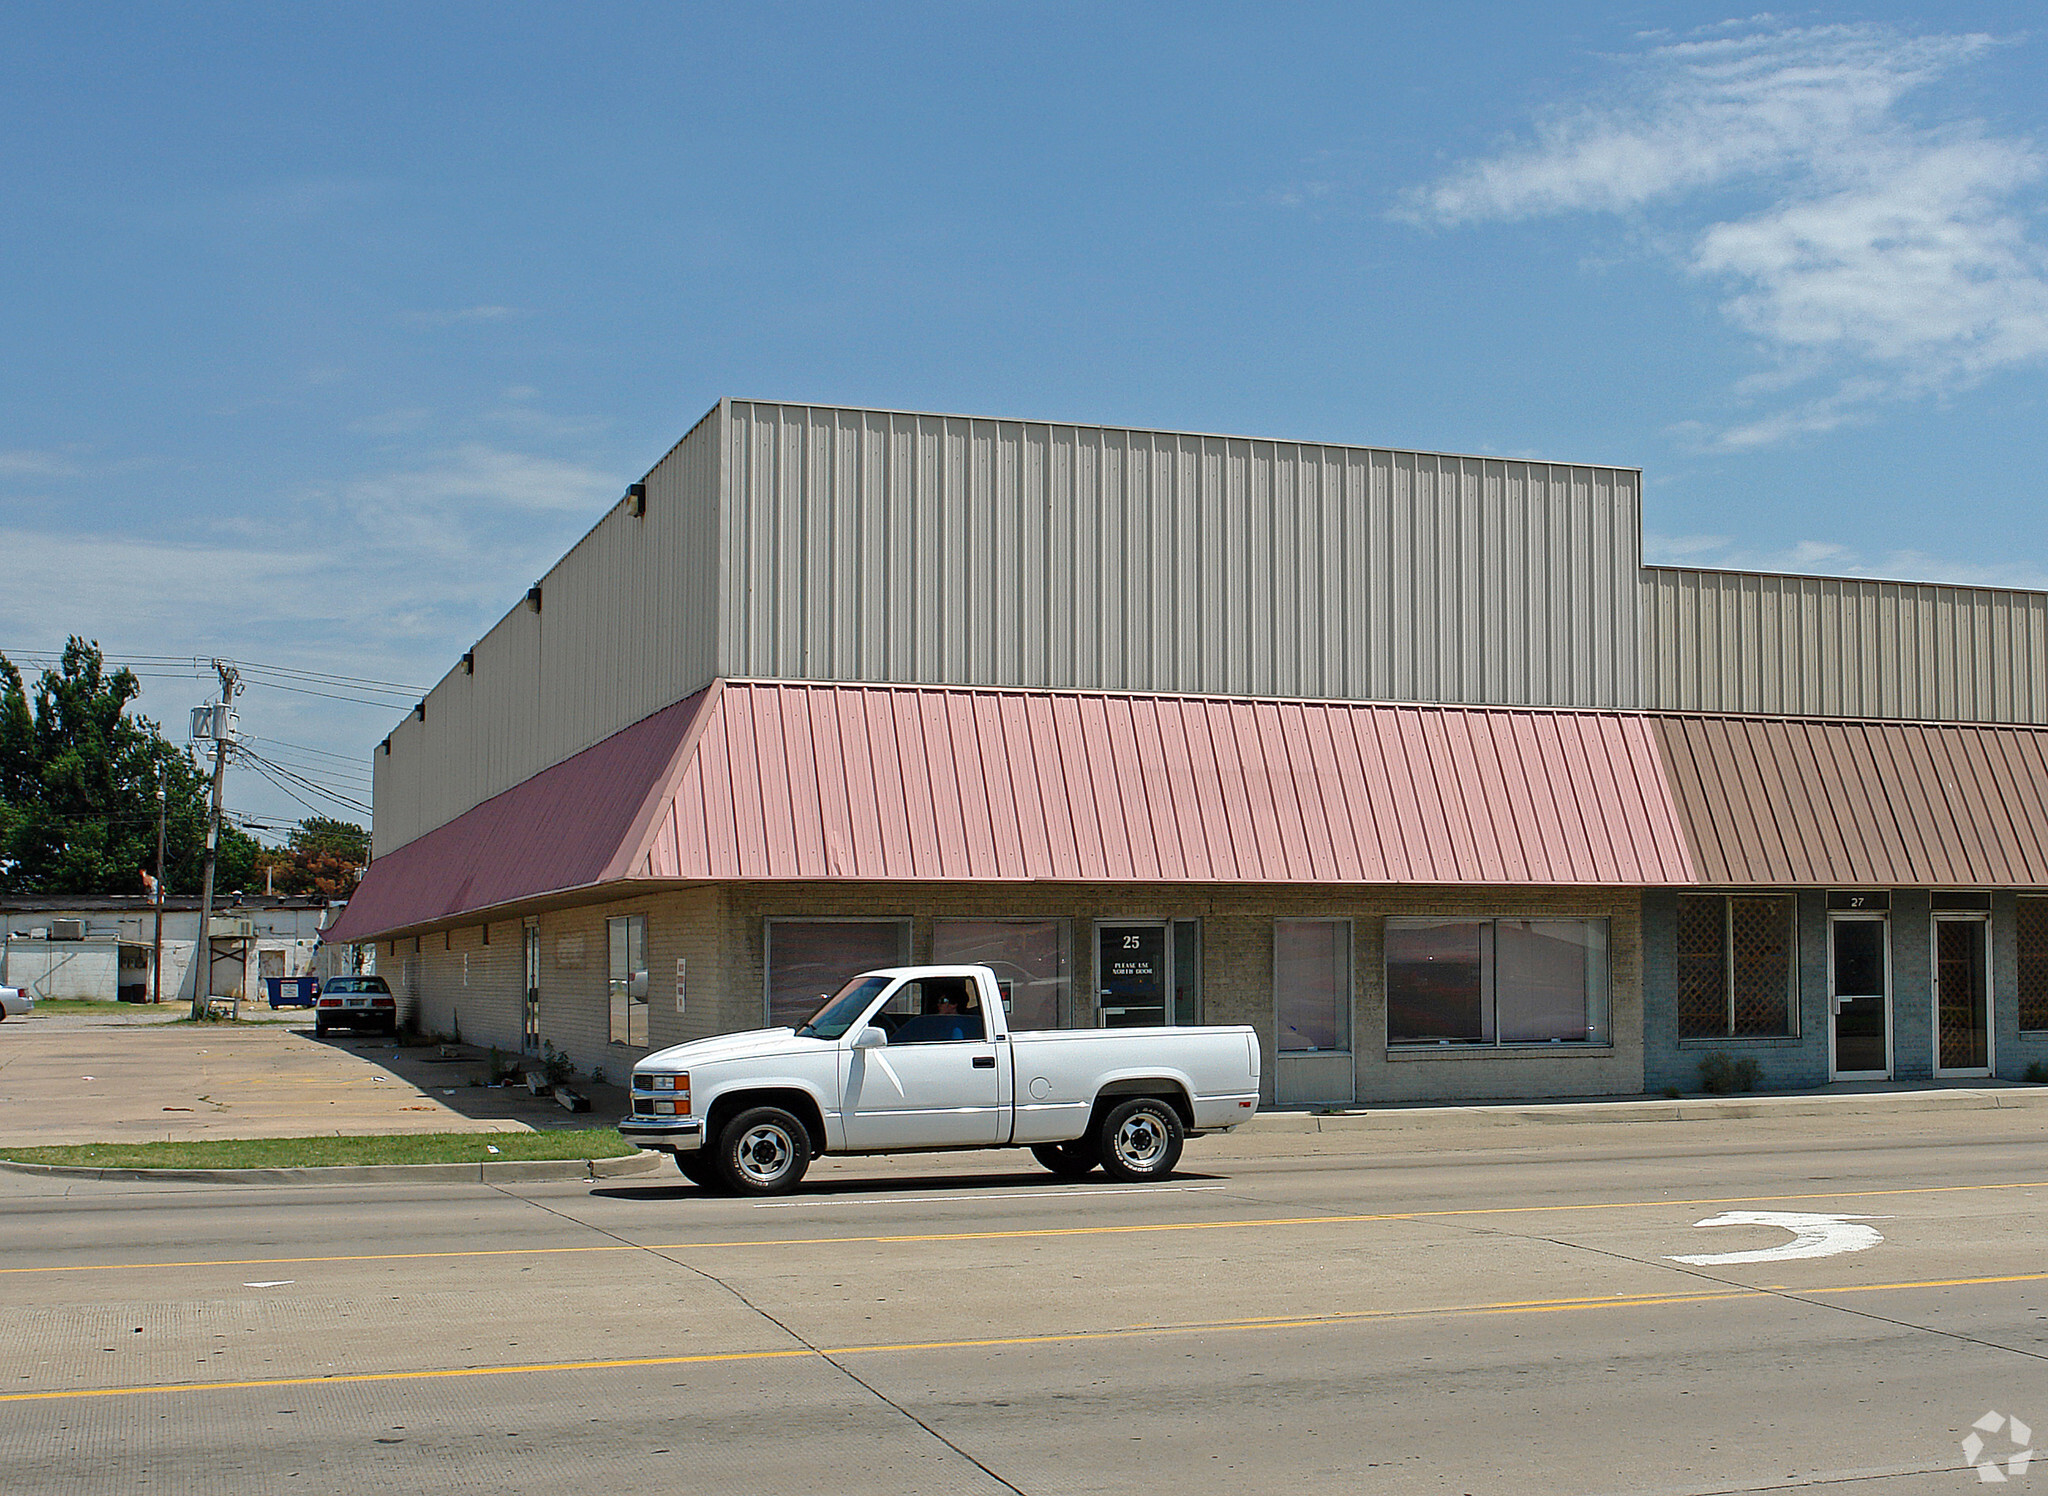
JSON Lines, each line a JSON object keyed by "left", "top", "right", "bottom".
{"left": 0, "top": 635, "right": 260, "bottom": 894}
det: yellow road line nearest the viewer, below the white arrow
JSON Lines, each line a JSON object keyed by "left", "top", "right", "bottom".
{"left": 0, "top": 1273, "right": 2048, "bottom": 1402}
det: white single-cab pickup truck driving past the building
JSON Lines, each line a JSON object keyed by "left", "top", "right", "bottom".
{"left": 618, "top": 965, "right": 1260, "bottom": 1195}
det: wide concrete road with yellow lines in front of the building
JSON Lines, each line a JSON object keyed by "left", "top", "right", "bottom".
{"left": 0, "top": 1111, "right": 2048, "bottom": 1496}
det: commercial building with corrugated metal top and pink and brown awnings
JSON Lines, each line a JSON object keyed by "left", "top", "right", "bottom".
{"left": 328, "top": 400, "right": 2048, "bottom": 1103}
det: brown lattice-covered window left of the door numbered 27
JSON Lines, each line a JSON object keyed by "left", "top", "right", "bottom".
{"left": 1677, "top": 894, "right": 1798, "bottom": 1039}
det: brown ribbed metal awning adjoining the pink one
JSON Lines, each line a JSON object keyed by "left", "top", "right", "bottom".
{"left": 1651, "top": 717, "right": 2048, "bottom": 887}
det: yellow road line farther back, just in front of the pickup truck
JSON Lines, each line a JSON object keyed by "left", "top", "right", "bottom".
{"left": 0, "top": 1180, "right": 2048, "bottom": 1277}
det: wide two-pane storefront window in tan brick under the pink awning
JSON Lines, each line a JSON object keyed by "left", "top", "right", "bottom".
{"left": 1386, "top": 918, "right": 1608, "bottom": 1045}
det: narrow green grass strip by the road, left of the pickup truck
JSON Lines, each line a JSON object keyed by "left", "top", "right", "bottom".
{"left": 0, "top": 1127, "right": 637, "bottom": 1168}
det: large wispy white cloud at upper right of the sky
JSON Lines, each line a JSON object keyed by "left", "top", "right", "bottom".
{"left": 1401, "top": 25, "right": 2048, "bottom": 449}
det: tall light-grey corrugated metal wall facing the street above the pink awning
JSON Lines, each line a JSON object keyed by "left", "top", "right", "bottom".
{"left": 719, "top": 402, "right": 1640, "bottom": 707}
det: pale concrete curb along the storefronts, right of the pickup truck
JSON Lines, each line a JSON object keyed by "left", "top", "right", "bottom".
{"left": 1235, "top": 1086, "right": 2048, "bottom": 1135}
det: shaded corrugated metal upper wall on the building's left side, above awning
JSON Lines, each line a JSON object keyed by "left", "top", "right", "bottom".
{"left": 373, "top": 410, "right": 721, "bottom": 855}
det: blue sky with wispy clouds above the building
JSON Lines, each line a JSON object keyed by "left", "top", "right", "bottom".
{"left": 0, "top": 0, "right": 2048, "bottom": 822}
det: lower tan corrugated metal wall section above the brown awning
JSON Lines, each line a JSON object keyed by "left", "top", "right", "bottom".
{"left": 1642, "top": 566, "right": 2048, "bottom": 723}
